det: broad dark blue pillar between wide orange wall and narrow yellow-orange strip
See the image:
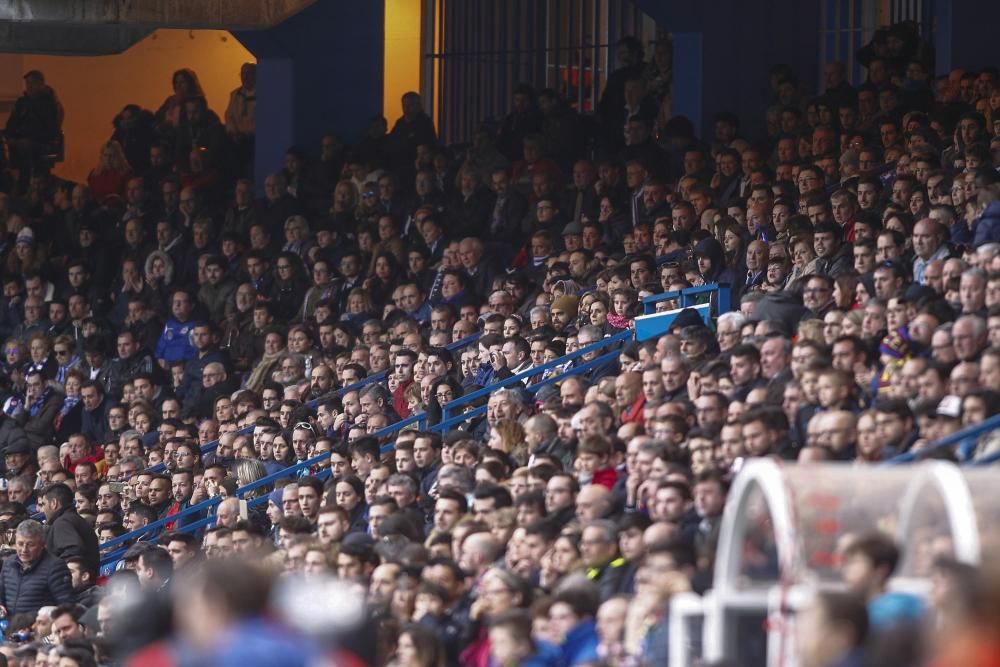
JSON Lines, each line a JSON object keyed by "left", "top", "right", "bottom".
{"left": 235, "top": 0, "right": 385, "bottom": 190}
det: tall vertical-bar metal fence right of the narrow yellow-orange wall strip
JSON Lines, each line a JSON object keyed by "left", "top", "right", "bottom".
{"left": 424, "top": 0, "right": 657, "bottom": 144}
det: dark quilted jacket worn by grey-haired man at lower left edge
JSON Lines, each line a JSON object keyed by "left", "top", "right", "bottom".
{"left": 0, "top": 548, "right": 74, "bottom": 618}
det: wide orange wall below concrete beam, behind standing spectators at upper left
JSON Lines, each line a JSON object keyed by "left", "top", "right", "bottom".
{"left": 11, "top": 30, "right": 254, "bottom": 181}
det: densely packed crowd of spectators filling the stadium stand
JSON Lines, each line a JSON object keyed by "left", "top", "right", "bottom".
{"left": 0, "top": 18, "right": 1000, "bottom": 667}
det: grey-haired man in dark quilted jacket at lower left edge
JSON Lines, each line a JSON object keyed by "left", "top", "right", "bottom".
{"left": 0, "top": 519, "right": 74, "bottom": 618}
